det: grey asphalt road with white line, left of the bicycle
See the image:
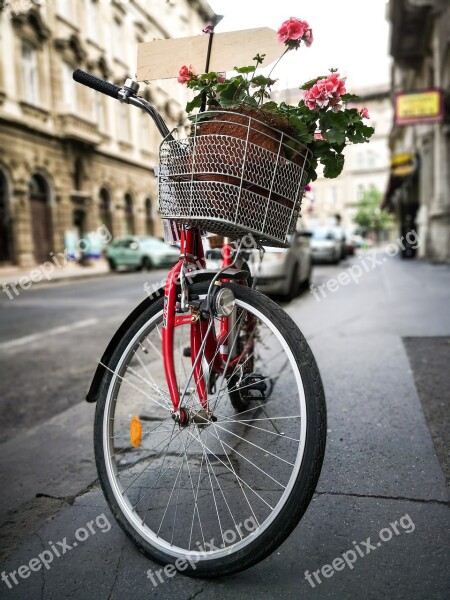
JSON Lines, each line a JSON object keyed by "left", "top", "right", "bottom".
{"left": 0, "top": 270, "right": 166, "bottom": 441}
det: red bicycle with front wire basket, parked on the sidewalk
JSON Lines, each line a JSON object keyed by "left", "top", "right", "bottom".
{"left": 74, "top": 70, "right": 326, "bottom": 577}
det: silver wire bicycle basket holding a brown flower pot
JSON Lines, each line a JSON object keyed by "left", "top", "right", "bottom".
{"left": 158, "top": 111, "right": 311, "bottom": 247}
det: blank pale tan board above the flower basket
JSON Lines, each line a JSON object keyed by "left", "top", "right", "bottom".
{"left": 136, "top": 27, "right": 286, "bottom": 81}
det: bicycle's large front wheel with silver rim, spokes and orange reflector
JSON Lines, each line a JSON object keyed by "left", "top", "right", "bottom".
{"left": 94, "top": 284, "right": 326, "bottom": 577}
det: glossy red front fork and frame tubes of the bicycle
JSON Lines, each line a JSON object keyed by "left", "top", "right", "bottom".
{"left": 162, "top": 229, "right": 253, "bottom": 412}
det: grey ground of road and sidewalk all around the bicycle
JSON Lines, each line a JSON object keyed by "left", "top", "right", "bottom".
{"left": 0, "top": 252, "right": 450, "bottom": 600}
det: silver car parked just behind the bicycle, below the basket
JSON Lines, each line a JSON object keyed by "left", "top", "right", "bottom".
{"left": 249, "top": 230, "right": 312, "bottom": 300}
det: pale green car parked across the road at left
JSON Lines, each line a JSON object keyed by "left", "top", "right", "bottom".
{"left": 106, "top": 236, "right": 179, "bottom": 271}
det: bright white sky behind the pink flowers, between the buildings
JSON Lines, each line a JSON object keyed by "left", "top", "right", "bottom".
{"left": 209, "top": 0, "right": 389, "bottom": 91}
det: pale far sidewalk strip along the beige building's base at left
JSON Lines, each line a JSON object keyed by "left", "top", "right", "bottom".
{"left": 0, "top": 258, "right": 110, "bottom": 295}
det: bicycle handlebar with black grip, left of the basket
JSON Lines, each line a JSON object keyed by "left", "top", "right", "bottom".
{"left": 72, "top": 69, "right": 174, "bottom": 140}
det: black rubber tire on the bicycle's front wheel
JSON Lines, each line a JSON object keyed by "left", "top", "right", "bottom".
{"left": 94, "top": 284, "right": 327, "bottom": 578}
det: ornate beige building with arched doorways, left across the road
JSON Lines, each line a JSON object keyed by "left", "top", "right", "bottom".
{"left": 0, "top": 0, "right": 214, "bottom": 267}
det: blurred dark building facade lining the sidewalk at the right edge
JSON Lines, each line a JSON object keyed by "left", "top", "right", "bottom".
{"left": 383, "top": 0, "right": 450, "bottom": 262}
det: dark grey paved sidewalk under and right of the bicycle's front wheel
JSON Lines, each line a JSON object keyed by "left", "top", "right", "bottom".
{"left": 0, "top": 254, "right": 450, "bottom": 600}
